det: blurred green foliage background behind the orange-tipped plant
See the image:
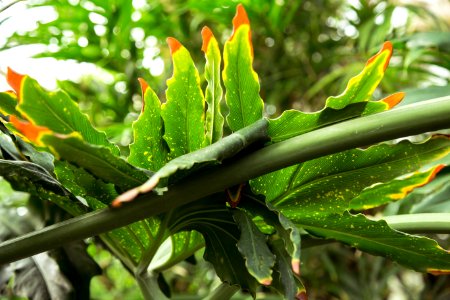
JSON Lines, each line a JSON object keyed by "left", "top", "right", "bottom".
{"left": 0, "top": 0, "right": 450, "bottom": 300}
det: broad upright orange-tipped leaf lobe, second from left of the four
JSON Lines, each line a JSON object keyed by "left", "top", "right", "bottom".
{"left": 161, "top": 38, "right": 205, "bottom": 158}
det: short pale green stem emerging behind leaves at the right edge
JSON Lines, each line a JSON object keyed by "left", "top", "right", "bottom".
{"left": 383, "top": 213, "right": 450, "bottom": 233}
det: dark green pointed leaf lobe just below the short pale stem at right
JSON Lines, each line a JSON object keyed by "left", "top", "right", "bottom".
{"left": 295, "top": 212, "right": 450, "bottom": 272}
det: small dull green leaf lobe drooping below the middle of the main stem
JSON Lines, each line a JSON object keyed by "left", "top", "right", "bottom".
{"left": 232, "top": 209, "right": 275, "bottom": 285}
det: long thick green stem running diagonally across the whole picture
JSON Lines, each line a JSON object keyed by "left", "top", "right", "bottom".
{"left": 0, "top": 97, "right": 450, "bottom": 264}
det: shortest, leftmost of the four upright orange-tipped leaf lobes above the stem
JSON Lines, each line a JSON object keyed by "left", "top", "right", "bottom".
{"left": 128, "top": 84, "right": 168, "bottom": 170}
